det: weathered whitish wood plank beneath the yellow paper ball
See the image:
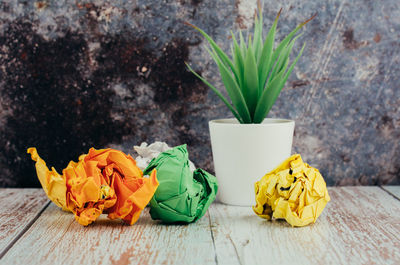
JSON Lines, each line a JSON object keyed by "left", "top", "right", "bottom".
{"left": 209, "top": 187, "right": 400, "bottom": 264}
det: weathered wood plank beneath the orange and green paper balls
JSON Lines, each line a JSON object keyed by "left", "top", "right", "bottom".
{"left": 3, "top": 204, "right": 215, "bottom": 264}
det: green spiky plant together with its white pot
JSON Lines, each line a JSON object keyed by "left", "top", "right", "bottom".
{"left": 187, "top": 5, "right": 314, "bottom": 206}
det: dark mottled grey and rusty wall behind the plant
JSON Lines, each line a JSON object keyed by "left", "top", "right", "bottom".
{"left": 0, "top": 0, "right": 400, "bottom": 187}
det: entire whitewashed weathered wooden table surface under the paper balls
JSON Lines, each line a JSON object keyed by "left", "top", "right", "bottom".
{"left": 0, "top": 186, "right": 400, "bottom": 264}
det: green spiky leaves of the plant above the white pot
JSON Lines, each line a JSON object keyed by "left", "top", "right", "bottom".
{"left": 186, "top": 5, "right": 315, "bottom": 123}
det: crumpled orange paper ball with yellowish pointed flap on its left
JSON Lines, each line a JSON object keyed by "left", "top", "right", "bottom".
{"left": 28, "top": 148, "right": 158, "bottom": 226}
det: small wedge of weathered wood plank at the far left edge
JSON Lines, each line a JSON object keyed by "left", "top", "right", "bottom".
{"left": 0, "top": 189, "right": 48, "bottom": 255}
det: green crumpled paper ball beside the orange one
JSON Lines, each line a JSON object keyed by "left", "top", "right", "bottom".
{"left": 143, "top": 145, "right": 218, "bottom": 223}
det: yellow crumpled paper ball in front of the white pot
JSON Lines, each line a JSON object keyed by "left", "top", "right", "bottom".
{"left": 253, "top": 154, "right": 330, "bottom": 226}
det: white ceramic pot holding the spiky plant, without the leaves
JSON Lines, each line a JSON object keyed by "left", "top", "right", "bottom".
{"left": 209, "top": 119, "right": 294, "bottom": 206}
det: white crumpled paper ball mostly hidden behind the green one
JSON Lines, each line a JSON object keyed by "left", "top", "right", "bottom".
{"left": 133, "top": 141, "right": 196, "bottom": 172}
